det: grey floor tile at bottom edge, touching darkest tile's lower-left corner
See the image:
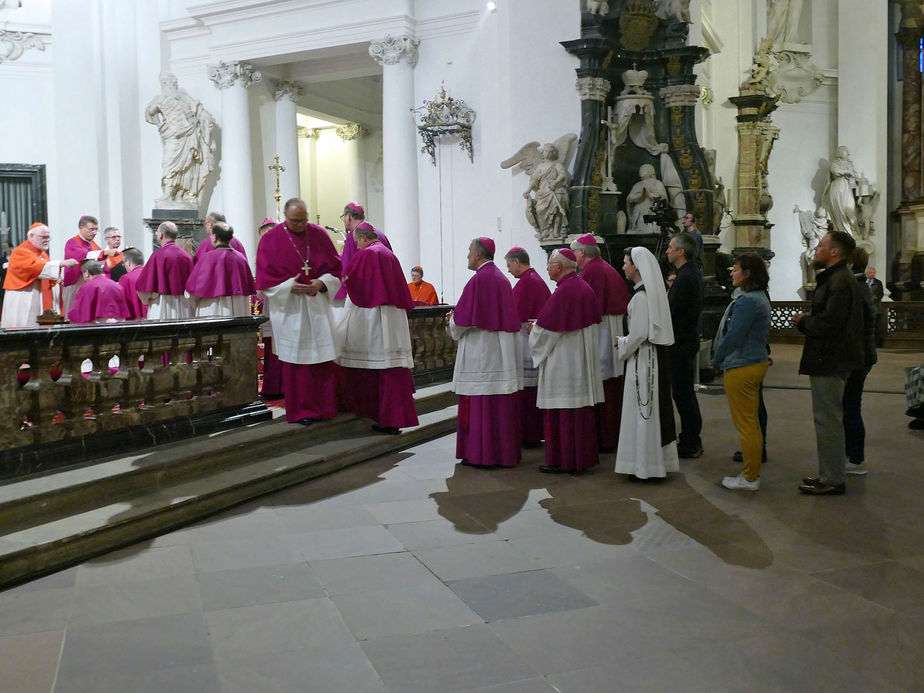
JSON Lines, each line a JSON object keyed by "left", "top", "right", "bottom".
{"left": 361, "top": 626, "right": 536, "bottom": 693}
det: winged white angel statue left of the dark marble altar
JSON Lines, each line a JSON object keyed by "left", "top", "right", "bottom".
{"left": 501, "top": 133, "right": 577, "bottom": 242}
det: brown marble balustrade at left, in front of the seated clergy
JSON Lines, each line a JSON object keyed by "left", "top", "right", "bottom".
{"left": 0, "top": 317, "right": 265, "bottom": 478}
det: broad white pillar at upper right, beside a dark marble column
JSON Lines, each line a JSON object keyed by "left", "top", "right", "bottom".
{"left": 831, "top": 0, "right": 889, "bottom": 272}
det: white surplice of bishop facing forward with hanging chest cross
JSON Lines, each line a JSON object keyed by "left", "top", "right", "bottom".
{"left": 263, "top": 274, "right": 340, "bottom": 364}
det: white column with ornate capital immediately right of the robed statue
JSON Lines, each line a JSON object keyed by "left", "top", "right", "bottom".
{"left": 209, "top": 62, "right": 263, "bottom": 263}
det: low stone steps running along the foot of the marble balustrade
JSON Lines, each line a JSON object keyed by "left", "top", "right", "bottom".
{"left": 0, "top": 392, "right": 456, "bottom": 589}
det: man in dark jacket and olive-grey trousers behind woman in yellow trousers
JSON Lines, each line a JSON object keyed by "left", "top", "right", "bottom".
{"left": 792, "top": 231, "right": 864, "bottom": 496}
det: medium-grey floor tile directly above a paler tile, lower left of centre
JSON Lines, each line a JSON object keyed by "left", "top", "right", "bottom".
{"left": 196, "top": 562, "right": 325, "bottom": 611}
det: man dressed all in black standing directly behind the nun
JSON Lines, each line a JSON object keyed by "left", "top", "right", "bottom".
{"left": 667, "top": 233, "right": 703, "bottom": 458}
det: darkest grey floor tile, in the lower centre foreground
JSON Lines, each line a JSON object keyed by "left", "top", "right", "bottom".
{"left": 449, "top": 570, "right": 597, "bottom": 622}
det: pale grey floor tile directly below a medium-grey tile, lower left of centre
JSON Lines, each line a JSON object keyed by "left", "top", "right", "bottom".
{"left": 205, "top": 598, "right": 355, "bottom": 661}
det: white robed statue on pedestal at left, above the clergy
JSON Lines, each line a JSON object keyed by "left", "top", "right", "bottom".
{"left": 144, "top": 72, "right": 215, "bottom": 209}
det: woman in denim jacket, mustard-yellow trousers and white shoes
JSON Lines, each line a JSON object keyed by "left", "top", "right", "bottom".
{"left": 712, "top": 253, "right": 770, "bottom": 491}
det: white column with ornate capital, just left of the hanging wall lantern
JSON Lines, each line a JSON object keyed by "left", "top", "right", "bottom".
{"left": 369, "top": 36, "right": 420, "bottom": 266}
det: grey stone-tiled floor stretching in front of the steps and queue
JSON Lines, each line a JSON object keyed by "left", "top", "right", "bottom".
{"left": 0, "top": 347, "right": 924, "bottom": 693}
